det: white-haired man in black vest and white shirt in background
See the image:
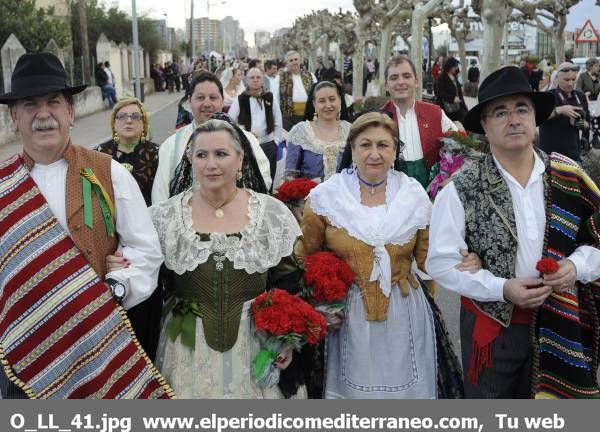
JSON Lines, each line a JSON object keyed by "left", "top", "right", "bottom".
{"left": 228, "top": 67, "right": 283, "bottom": 189}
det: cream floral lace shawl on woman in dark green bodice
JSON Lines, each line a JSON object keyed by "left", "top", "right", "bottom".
{"left": 150, "top": 190, "right": 302, "bottom": 274}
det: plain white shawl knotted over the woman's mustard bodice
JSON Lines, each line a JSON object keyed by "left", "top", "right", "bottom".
{"left": 309, "top": 169, "right": 432, "bottom": 296}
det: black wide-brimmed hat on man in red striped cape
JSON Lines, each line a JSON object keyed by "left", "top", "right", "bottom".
{"left": 0, "top": 53, "right": 87, "bottom": 104}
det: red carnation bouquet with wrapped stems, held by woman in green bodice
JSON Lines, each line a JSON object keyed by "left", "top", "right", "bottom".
{"left": 251, "top": 288, "right": 327, "bottom": 387}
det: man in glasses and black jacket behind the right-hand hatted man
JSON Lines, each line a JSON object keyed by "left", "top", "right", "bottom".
{"left": 539, "top": 62, "right": 590, "bottom": 163}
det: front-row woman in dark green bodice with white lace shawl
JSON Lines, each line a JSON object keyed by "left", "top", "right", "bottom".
{"left": 152, "top": 120, "right": 304, "bottom": 399}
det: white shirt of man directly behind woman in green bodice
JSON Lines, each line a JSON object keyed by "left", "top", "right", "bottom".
{"left": 152, "top": 121, "right": 271, "bottom": 204}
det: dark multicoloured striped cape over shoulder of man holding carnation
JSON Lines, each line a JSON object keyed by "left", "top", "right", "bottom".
{"left": 532, "top": 153, "right": 600, "bottom": 399}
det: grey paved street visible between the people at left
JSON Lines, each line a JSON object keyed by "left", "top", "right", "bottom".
{"left": 0, "top": 91, "right": 184, "bottom": 160}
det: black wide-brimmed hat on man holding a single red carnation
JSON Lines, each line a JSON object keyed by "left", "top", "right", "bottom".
{"left": 463, "top": 66, "right": 554, "bottom": 134}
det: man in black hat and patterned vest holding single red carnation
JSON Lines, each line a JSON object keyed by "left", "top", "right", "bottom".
{"left": 427, "top": 66, "right": 600, "bottom": 398}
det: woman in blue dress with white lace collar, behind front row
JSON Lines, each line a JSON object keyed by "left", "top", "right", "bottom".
{"left": 285, "top": 81, "right": 352, "bottom": 182}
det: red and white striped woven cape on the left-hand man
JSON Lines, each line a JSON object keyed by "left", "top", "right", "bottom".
{"left": 0, "top": 156, "right": 173, "bottom": 399}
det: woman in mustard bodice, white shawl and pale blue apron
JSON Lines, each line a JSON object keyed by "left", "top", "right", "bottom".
{"left": 295, "top": 112, "right": 462, "bottom": 399}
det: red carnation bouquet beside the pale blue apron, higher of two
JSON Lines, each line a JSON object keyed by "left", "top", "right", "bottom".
{"left": 303, "top": 252, "right": 354, "bottom": 314}
